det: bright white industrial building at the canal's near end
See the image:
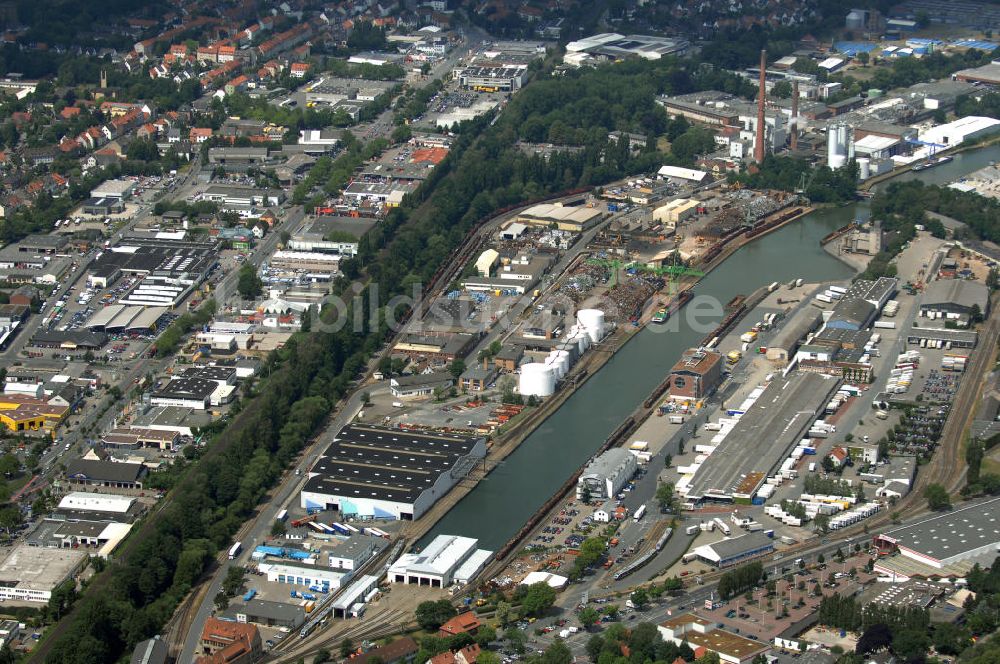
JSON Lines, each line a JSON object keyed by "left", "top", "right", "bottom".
{"left": 387, "top": 535, "right": 493, "bottom": 588}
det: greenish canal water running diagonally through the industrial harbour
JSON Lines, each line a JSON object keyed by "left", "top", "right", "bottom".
{"left": 421, "top": 148, "right": 997, "bottom": 550}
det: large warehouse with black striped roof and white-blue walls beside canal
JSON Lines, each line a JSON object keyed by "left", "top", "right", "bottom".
{"left": 300, "top": 425, "right": 486, "bottom": 520}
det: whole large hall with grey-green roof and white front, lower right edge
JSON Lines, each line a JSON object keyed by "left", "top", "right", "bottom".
{"left": 874, "top": 498, "right": 1000, "bottom": 570}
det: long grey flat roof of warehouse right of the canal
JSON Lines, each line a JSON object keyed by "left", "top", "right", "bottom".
{"left": 688, "top": 372, "right": 840, "bottom": 499}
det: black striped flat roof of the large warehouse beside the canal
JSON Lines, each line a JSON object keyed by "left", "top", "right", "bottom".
{"left": 303, "top": 425, "right": 481, "bottom": 502}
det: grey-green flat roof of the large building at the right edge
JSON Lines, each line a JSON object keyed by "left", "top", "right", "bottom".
{"left": 880, "top": 498, "right": 1000, "bottom": 561}
